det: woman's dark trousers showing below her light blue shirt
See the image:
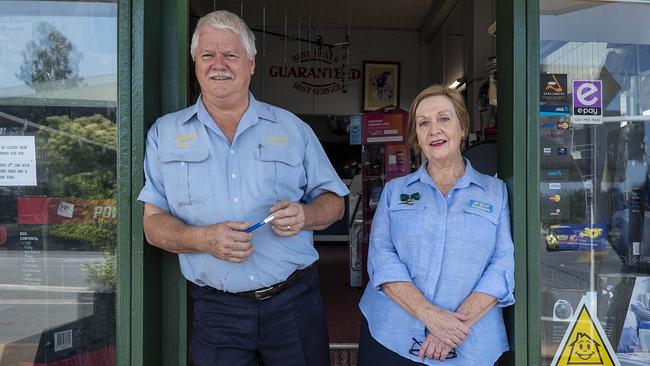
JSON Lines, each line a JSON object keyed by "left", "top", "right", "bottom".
{"left": 357, "top": 316, "right": 422, "bottom": 366}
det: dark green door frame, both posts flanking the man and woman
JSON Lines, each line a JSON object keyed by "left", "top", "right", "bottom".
{"left": 117, "top": 0, "right": 540, "bottom": 366}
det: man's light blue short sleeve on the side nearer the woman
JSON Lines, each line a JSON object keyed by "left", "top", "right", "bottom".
{"left": 304, "top": 126, "right": 350, "bottom": 202}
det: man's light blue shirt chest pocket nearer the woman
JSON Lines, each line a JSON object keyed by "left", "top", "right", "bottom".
{"left": 255, "top": 146, "right": 307, "bottom": 202}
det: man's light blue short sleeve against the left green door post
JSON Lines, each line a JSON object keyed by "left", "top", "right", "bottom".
{"left": 138, "top": 124, "right": 169, "bottom": 211}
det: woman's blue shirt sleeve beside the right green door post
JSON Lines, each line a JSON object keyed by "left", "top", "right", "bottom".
{"left": 474, "top": 183, "right": 515, "bottom": 307}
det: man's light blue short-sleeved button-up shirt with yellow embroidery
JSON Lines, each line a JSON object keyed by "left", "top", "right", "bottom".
{"left": 138, "top": 94, "right": 349, "bottom": 292}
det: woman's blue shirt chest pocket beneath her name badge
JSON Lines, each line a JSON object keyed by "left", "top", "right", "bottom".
{"left": 463, "top": 206, "right": 499, "bottom": 258}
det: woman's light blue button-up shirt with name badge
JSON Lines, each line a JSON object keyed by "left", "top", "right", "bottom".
{"left": 360, "top": 160, "right": 514, "bottom": 365}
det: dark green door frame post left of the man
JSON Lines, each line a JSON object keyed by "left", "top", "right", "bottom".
{"left": 117, "top": 0, "right": 189, "bottom": 366}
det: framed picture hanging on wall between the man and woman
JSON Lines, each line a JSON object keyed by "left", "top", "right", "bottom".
{"left": 362, "top": 61, "right": 400, "bottom": 112}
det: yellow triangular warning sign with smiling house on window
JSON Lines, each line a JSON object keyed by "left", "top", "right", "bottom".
{"left": 551, "top": 297, "right": 620, "bottom": 366}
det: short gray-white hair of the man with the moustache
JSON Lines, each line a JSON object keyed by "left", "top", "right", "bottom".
{"left": 190, "top": 10, "right": 257, "bottom": 60}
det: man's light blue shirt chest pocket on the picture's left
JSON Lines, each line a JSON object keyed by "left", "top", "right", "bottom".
{"left": 158, "top": 149, "right": 211, "bottom": 206}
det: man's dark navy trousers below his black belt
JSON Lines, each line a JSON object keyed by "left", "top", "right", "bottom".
{"left": 187, "top": 268, "right": 330, "bottom": 366}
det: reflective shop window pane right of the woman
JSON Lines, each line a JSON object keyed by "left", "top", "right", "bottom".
{"left": 538, "top": 0, "right": 650, "bottom": 365}
